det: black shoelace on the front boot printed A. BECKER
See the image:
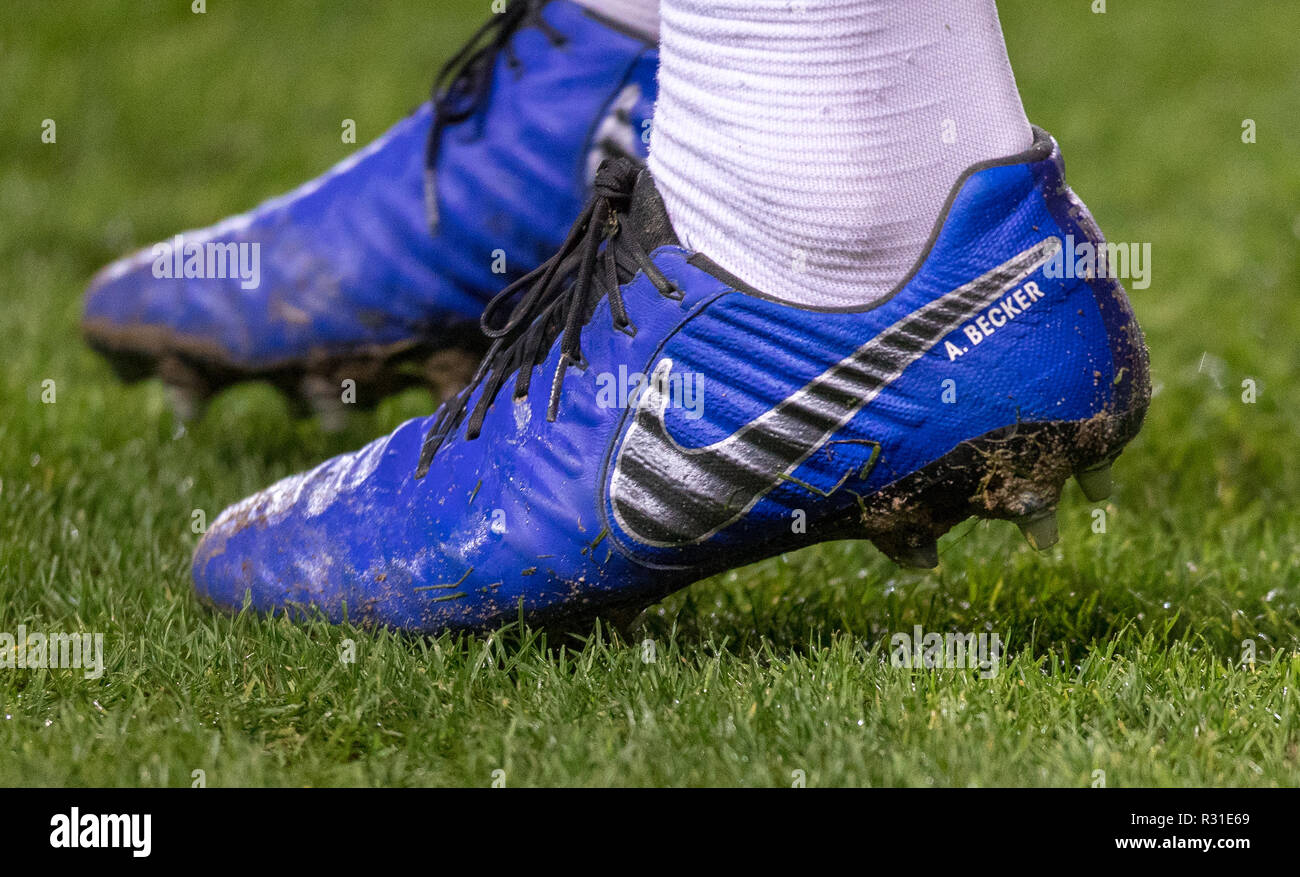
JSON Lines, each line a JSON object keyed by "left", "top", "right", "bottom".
{"left": 416, "top": 159, "right": 683, "bottom": 478}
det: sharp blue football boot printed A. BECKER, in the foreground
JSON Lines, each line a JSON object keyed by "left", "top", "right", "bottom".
{"left": 194, "top": 125, "right": 1149, "bottom": 631}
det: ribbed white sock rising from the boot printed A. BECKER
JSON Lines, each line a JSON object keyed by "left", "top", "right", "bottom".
{"left": 650, "top": 0, "right": 1034, "bottom": 307}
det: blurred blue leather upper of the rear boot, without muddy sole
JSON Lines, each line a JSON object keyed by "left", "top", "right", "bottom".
{"left": 86, "top": 0, "right": 658, "bottom": 370}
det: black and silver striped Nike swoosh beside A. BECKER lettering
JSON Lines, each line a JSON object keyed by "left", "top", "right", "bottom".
{"left": 610, "top": 236, "right": 1061, "bottom": 547}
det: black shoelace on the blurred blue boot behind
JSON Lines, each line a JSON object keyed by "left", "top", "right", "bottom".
{"left": 424, "top": 0, "right": 568, "bottom": 226}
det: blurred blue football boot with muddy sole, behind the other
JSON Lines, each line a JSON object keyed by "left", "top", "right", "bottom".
{"left": 83, "top": 0, "right": 658, "bottom": 426}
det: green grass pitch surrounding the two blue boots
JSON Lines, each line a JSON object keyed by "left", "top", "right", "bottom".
{"left": 0, "top": 0, "right": 1300, "bottom": 786}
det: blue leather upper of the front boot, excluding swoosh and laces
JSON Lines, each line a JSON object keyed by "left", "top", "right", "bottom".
{"left": 194, "top": 131, "right": 1136, "bottom": 630}
